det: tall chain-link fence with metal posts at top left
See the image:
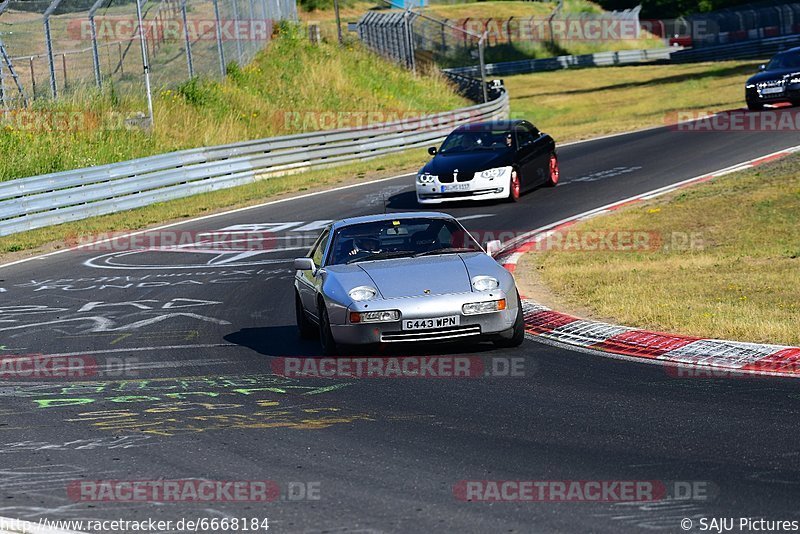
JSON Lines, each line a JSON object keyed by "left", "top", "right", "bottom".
{"left": 0, "top": 0, "right": 297, "bottom": 114}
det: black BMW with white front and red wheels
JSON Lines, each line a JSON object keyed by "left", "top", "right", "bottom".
{"left": 416, "top": 120, "right": 559, "bottom": 204}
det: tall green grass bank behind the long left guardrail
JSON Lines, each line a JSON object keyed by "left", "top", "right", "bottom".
{"left": 0, "top": 25, "right": 468, "bottom": 181}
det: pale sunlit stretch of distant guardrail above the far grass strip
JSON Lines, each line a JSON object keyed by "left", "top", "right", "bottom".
{"left": 444, "top": 47, "right": 681, "bottom": 76}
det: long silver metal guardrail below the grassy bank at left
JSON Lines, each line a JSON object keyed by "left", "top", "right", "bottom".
{"left": 0, "top": 90, "right": 508, "bottom": 235}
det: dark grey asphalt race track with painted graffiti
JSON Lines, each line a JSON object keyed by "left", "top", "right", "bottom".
{"left": 0, "top": 119, "right": 800, "bottom": 532}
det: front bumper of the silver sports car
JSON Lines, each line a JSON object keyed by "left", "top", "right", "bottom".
{"left": 331, "top": 290, "right": 518, "bottom": 345}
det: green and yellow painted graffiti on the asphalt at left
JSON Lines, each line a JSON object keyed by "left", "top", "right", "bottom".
{"left": 0, "top": 374, "right": 372, "bottom": 436}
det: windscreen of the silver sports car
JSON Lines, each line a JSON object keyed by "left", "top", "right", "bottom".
{"left": 329, "top": 218, "right": 482, "bottom": 264}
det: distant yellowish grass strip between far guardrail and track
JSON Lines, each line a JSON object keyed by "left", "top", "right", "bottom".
{"left": 504, "top": 61, "right": 759, "bottom": 141}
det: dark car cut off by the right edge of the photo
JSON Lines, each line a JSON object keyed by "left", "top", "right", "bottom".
{"left": 744, "top": 48, "right": 800, "bottom": 111}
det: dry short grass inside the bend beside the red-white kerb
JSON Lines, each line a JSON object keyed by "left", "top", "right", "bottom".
{"left": 518, "top": 156, "right": 800, "bottom": 345}
